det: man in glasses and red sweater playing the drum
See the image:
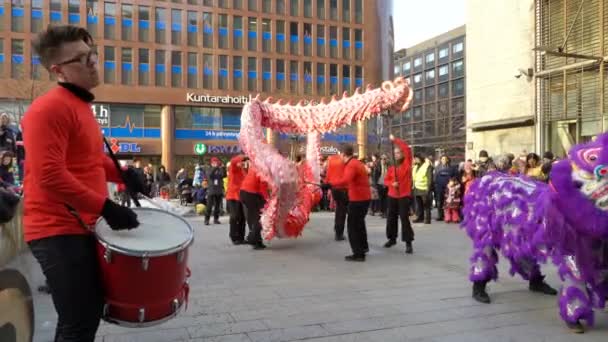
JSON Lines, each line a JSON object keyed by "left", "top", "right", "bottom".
{"left": 22, "top": 26, "right": 143, "bottom": 342}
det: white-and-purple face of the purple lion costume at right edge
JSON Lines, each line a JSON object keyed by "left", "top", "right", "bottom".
{"left": 568, "top": 133, "right": 608, "bottom": 211}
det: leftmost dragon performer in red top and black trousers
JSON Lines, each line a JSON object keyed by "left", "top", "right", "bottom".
{"left": 226, "top": 155, "right": 249, "bottom": 245}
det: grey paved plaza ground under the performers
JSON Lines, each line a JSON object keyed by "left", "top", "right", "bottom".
{"left": 8, "top": 213, "right": 608, "bottom": 342}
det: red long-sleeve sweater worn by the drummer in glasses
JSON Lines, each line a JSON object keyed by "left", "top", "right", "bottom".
{"left": 22, "top": 86, "right": 120, "bottom": 241}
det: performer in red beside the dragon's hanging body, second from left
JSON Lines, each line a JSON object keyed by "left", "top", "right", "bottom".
{"left": 240, "top": 168, "right": 268, "bottom": 250}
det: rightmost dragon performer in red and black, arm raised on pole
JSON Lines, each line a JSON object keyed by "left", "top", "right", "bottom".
{"left": 384, "top": 134, "right": 414, "bottom": 254}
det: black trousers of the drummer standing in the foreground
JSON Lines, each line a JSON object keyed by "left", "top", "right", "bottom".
{"left": 29, "top": 235, "right": 104, "bottom": 342}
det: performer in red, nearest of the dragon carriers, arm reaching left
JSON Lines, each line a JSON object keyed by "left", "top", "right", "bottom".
{"left": 330, "top": 145, "right": 371, "bottom": 261}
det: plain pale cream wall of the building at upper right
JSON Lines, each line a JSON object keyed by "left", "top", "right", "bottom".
{"left": 466, "top": 0, "right": 536, "bottom": 158}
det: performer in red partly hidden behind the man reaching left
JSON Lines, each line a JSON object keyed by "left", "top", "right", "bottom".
{"left": 325, "top": 154, "right": 348, "bottom": 241}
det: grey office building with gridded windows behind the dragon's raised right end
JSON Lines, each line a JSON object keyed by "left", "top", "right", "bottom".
{"left": 390, "top": 26, "right": 466, "bottom": 160}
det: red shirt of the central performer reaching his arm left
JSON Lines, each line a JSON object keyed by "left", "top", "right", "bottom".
{"left": 329, "top": 158, "right": 372, "bottom": 202}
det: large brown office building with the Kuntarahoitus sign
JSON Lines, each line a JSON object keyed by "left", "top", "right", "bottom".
{"left": 0, "top": 0, "right": 392, "bottom": 171}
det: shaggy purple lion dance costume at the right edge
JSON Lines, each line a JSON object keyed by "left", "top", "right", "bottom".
{"left": 462, "top": 133, "right": 608, "bottom": 332}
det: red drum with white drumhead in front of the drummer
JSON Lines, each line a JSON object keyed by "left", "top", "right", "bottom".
{"left": 95, "top": 208, "right": 194, "bottom": 327}
